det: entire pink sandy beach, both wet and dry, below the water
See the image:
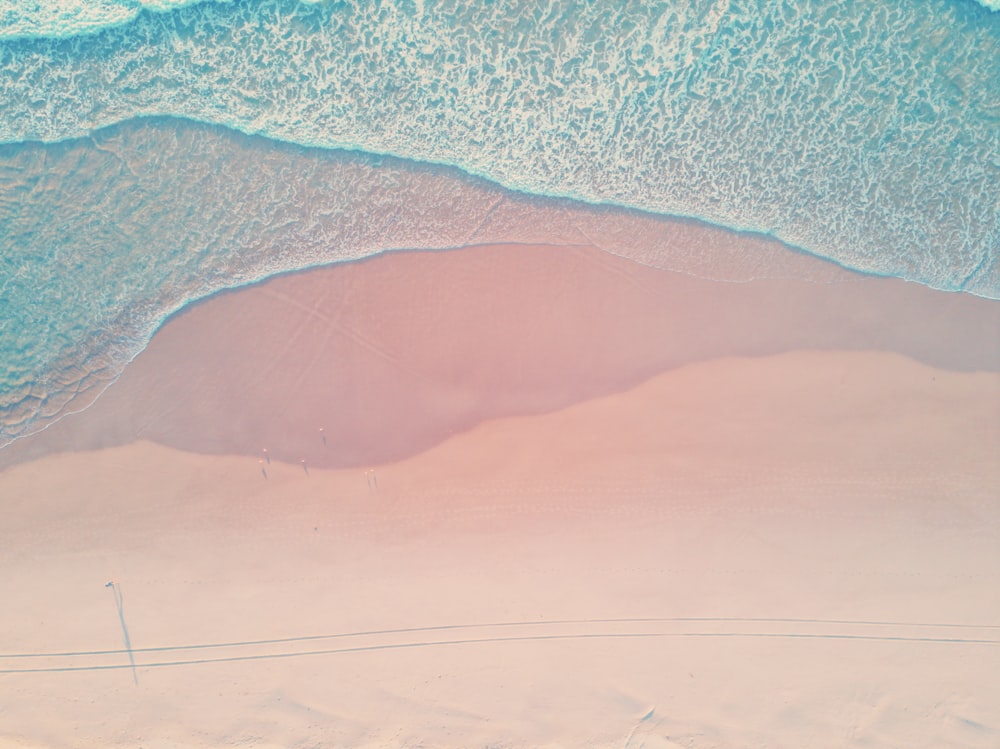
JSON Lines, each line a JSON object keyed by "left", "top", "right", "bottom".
{"left": 0, "top": 247, "right": 1000, "bottom": 749}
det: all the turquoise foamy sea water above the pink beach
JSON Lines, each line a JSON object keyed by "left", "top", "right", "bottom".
{"left": 0, "top": 0, "right": 1000, "bottom": 445}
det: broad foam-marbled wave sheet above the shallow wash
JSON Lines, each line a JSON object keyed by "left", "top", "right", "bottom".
{"left": 0, "top": 0, "right": 1000, "bottom": 296}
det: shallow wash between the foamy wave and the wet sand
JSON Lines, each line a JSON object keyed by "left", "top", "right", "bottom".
{"left": 0, "top": 118, "right": 988, "bottom": 450}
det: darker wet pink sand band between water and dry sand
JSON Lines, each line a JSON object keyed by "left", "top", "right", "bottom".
{"left": 0, "top": 245, "right": 1000, "bottom": 469}
